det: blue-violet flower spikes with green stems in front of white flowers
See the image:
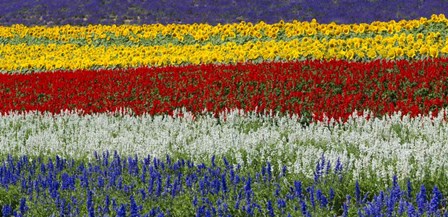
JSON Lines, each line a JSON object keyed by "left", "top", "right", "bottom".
{"left": 0, "top": 152, "right": 447, "bottom": 217}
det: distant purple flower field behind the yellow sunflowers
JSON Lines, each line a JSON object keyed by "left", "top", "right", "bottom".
{"left": 0, "top": 0, "right": 448, "bottom": 25}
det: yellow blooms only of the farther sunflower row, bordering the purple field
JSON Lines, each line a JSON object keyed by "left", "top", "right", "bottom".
{"left": 0, "top": 14, "right": 448, "bottom": 43}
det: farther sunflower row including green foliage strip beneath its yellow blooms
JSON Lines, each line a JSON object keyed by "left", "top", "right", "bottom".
{"left": 0, "top": 14, "right": 448, "bottom": 45}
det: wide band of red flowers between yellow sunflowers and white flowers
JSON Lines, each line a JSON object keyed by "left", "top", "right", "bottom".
{"left": 0, "top": 59, "right": 448, "bottom": 119}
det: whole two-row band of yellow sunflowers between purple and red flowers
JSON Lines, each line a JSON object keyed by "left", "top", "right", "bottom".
{"left": 0, "top": 14, "right": 448, "bottom": 72}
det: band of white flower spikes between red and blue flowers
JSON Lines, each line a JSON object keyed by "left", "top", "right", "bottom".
{"left": 0, "top": 110, "right": 448, "bottom": 181}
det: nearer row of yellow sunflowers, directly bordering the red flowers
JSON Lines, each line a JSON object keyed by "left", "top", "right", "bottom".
{"left": 0, "top": 33, "right": 448, "bottom": 72}
